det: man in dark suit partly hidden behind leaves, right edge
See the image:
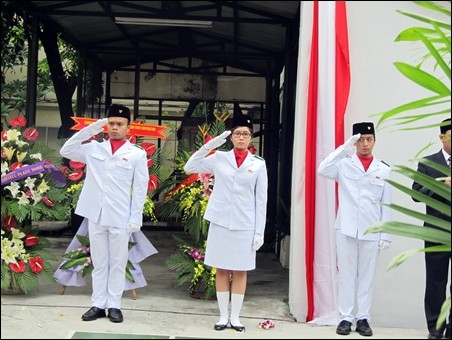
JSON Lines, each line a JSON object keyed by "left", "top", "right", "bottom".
{"left": 412, "top": 118, "right": 452, "bottom": 339}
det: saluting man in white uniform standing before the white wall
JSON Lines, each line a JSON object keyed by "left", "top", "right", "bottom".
{"left": 317, "top": 122, "right": 391, "bottom": 336}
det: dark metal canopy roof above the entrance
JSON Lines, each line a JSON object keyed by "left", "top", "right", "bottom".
{"left": 20, "top": 1, "right": 300, "bottom": 76}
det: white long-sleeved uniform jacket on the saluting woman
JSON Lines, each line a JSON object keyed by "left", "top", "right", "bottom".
{"left": 184, "top": 147, "right": 268, "bottom": 234}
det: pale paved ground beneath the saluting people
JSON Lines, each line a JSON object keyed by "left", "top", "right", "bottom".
{"left": 1, "top": 229, "right": 426, "bottom": 339}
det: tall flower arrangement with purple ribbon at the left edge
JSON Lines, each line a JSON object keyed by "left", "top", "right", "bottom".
{"left": 1, "top": 116, "right": 67, "bottom": 293}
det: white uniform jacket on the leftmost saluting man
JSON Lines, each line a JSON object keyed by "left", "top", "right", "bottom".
{"left": 60, "top": 129, "right": 149, "bottom": 228}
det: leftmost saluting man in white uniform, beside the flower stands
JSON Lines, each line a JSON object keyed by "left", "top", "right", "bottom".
{"left": 60, "top": 104, "right": 149, "bottom": 322}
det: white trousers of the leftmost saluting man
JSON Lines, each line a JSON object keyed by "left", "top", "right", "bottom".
{"left": 88, "top": 221, "right": 130, "bottom": 309}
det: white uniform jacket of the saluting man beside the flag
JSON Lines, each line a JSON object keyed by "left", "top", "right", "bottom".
{"left": 317, "top": 146, "right": 391, "bottom": 241}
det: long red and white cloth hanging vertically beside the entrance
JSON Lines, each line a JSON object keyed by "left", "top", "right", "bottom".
{"left": 289, "top": 1, "right": 350, "bottom": 324}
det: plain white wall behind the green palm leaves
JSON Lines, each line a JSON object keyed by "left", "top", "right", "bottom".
{"left": 345, "top": 1, "right": 450, "bottom": 328}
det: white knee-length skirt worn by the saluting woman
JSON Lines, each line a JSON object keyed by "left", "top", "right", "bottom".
{"left": 204, "top": 223, "right": 256, "bottom": 271}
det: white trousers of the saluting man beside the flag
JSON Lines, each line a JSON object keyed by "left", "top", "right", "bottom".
{"left": 336, "top": 231, "right": 379, "bottom": 323}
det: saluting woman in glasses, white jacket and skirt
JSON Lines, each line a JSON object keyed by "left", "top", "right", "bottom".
{"left": 185, "top": 114, "right": 268, "bottom": 332}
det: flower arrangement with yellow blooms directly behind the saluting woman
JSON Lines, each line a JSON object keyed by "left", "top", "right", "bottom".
{"left": 160, "top": 114, "right": 229, "bottom": 299}
